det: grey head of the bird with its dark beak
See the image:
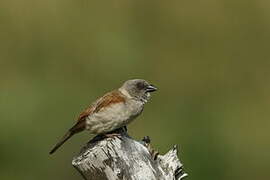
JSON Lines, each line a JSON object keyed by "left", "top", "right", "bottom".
{"left": 119, "top": 79, "right": 157, "bottom": 103}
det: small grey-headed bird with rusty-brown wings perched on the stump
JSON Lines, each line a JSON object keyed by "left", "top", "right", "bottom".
{"left": 50, "top": 79, "right": 157, "bottom": 154}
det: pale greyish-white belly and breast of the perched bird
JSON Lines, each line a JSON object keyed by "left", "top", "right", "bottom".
{"left": 86, "top": 100, "right": 143, "bottom": 134}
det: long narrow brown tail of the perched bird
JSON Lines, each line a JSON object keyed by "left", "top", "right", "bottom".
{"left": 50, "top": 120, "right": 85, "bottom": 154}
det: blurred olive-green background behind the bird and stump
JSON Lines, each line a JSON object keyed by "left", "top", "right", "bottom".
{"left": 0, "top": 0, "right": 270, "bottom": 180}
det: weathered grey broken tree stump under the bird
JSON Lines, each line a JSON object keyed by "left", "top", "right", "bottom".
{"left": 72, "top": 129, "right": 187, "bottom": 180}
